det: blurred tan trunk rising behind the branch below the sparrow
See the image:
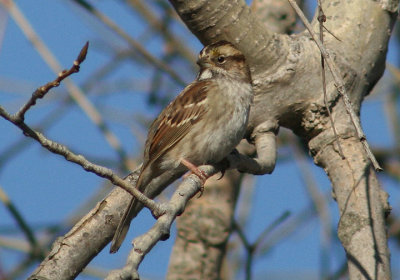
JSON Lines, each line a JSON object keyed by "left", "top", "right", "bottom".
{"left": 167, "top": 170, "right": 242, "bottom": 280}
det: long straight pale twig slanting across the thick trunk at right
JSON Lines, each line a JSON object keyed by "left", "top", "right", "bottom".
{"left": 288, "top": 0, "right": 383, "bottom": 171}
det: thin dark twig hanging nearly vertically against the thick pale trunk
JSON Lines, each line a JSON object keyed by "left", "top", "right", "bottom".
{"left": 318, "top": 0, "right": 345, "bottom": 159}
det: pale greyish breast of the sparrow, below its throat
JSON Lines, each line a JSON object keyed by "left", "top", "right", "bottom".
{"left": 185, "top": 77, "right": 253, "bottom": 165}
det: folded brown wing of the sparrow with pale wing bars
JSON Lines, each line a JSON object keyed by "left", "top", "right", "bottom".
{"left": 143, "top": 81, "right": 211, "bottom": 169}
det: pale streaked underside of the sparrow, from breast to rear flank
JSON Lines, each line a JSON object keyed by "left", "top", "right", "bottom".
{"left": 162, "top": 77, "right": 252, "bottom": 169}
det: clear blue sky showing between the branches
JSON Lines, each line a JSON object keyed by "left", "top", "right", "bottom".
{"left": 0, "top": 0, "right": 400, "bottom": 279}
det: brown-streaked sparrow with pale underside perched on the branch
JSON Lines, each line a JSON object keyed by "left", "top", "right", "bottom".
{"left": 110, "top": 41, "right": 253, "bottom": 253}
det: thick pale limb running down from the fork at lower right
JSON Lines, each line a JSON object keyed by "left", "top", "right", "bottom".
{"left": 315, "top": 138, "right": 391, "bottom": 279}
